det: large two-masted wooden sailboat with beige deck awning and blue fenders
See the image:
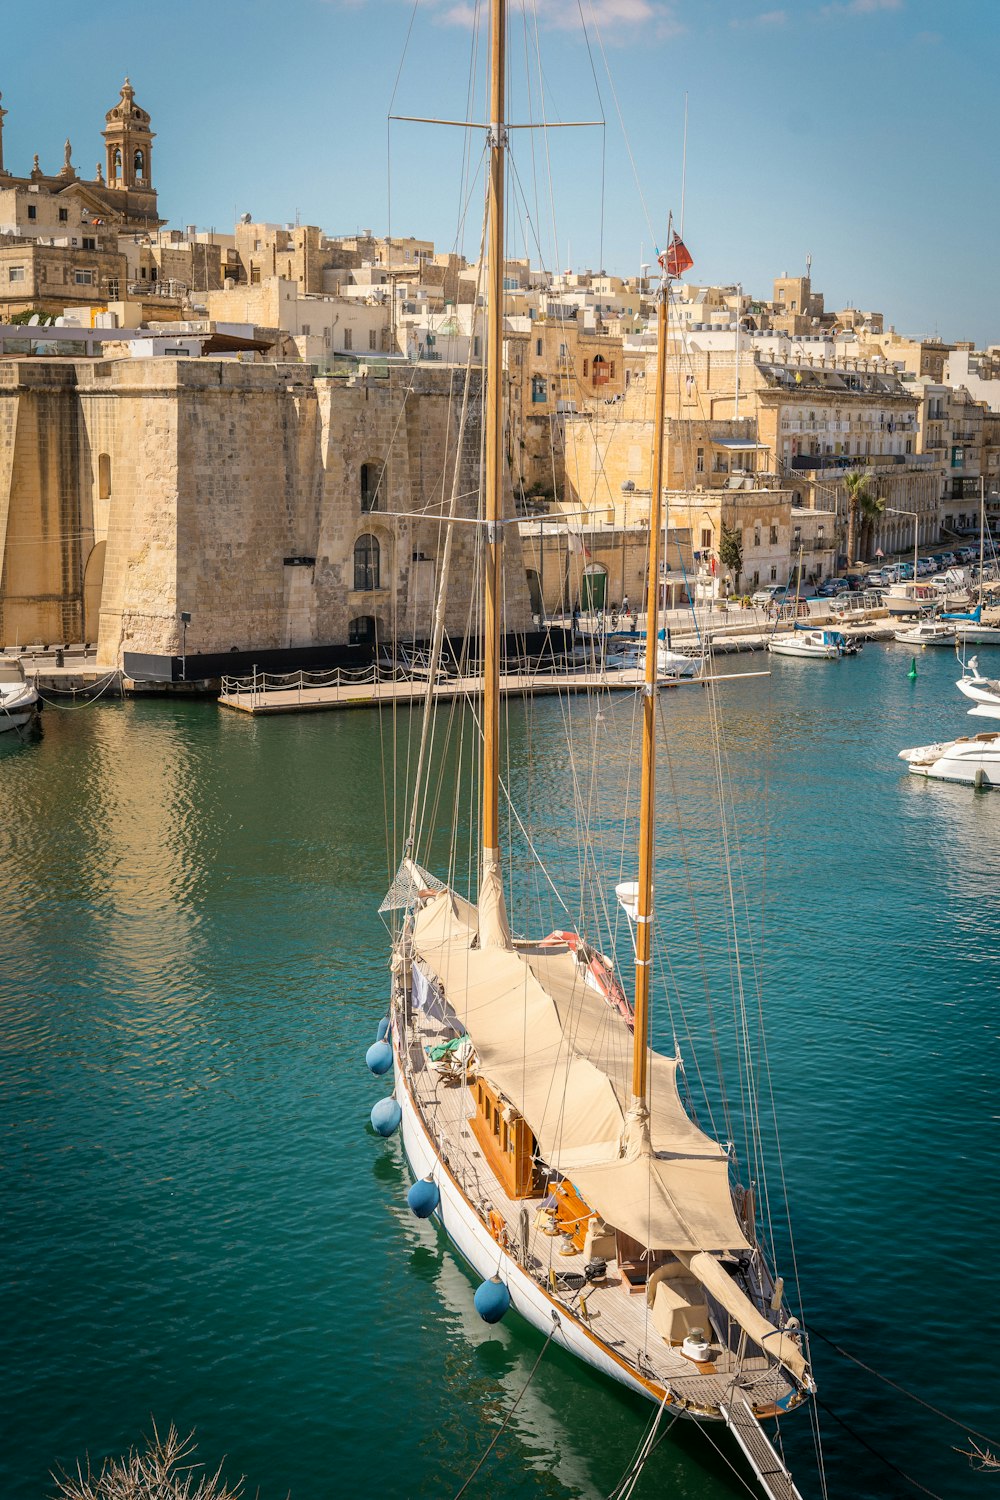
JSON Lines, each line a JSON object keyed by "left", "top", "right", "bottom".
{"left": 367, "top": 0, "right": 814, "bottom": 1497}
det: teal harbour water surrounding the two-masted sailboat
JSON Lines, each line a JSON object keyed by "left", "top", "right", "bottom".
{"left": 0, "top": 647, "right": 1000, "bottom": 1500}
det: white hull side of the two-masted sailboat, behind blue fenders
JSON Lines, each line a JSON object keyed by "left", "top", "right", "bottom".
{"left": 393, "top": 1040, "right": 680, "bottom": 1421}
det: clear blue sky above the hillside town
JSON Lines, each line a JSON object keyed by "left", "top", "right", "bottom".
{"left": 0, "top": 0, "right": 1000, "bottom": 344}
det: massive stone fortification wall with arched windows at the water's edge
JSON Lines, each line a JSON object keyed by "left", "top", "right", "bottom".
{"left": 0, "top": 359, "right": 531, "bottom": 666}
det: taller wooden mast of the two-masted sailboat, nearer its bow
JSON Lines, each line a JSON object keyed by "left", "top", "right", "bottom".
{"left": 480, "top": 0, "right": 510, "bottom": 948}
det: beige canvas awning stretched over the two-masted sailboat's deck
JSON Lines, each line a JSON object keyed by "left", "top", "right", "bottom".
{"left": 414, "top": 891, "right": 747, "bottom": 1251}
